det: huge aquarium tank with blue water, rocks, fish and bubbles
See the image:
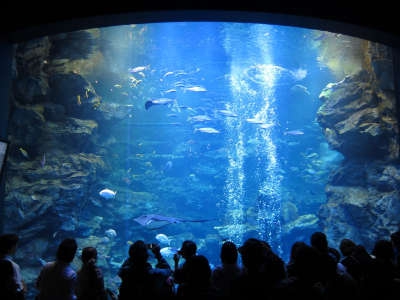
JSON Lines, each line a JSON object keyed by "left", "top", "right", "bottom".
{"left": 3, "top": 22, "right": 400, "bottom": 298}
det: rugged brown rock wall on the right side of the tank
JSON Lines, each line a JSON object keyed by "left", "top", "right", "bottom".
{"left": 317, "top": 42, "right": 400, "bottom": 249}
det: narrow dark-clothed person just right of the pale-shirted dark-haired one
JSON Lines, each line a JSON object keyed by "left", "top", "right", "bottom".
{"left": 76, "top": 247, "right": 107, "bottom": 300}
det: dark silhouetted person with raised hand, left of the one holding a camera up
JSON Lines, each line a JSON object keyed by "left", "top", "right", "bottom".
{"left": 118, "top": 240, "right": 172, "bottom": 300}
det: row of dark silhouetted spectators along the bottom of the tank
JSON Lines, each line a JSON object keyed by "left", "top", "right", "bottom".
{"left": 0, "top": 231, "right": 400, "bottom": 300}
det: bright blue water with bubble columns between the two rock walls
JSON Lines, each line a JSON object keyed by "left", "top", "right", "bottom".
{"left": 14, "top": 22, "right": 348, "bottom": 296}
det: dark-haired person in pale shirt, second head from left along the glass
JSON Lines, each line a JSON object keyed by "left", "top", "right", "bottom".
{"left": 36, "top": 238, "right": 78, "bottom": 300}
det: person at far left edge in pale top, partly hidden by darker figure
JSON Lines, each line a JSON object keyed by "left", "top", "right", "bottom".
{"left": 0, "top": 233, "right": 27, "bottom": 299}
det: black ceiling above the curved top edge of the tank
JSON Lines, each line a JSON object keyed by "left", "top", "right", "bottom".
{"left": 0, "top": 0, "right": 400, "bottom": 47}
